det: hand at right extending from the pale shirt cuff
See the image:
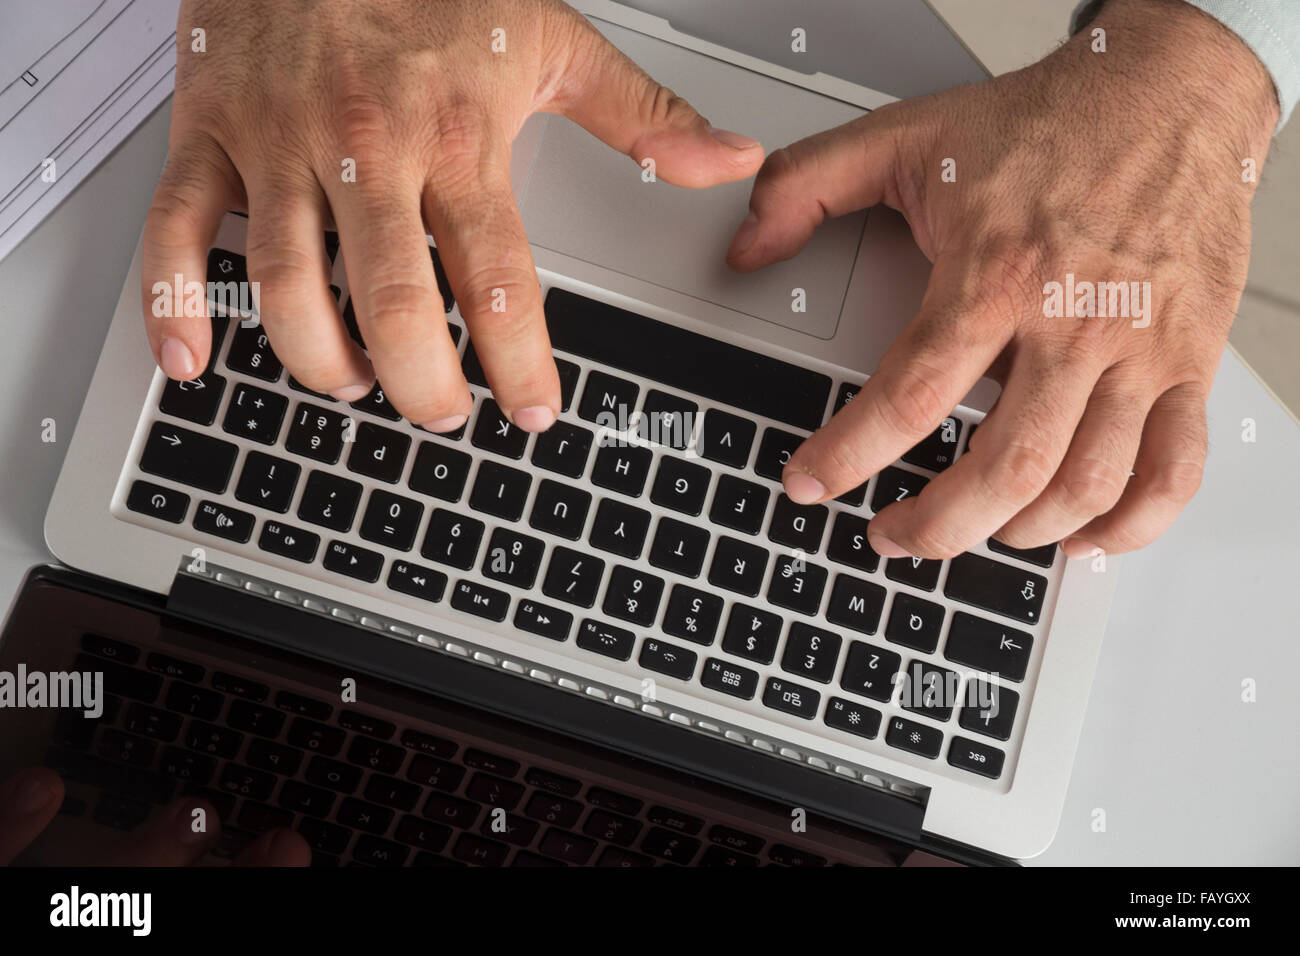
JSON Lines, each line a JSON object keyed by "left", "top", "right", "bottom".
{"left": 728, "top": 0, "right": 1278, "bottom": 558}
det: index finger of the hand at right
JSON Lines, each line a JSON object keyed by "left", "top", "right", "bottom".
{"left": 781, "top": 263, "right": 1011, "bottom": 505}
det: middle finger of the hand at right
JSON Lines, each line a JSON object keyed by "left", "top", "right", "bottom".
{"left": 854, "top": 343, "right": 1102, "bottom": 558}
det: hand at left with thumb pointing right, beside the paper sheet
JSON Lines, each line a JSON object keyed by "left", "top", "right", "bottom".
{"left": 142, "top": 0, "right": 763, "bottom": 432}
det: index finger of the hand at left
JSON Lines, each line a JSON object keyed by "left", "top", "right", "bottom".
{"left": 424, "top": 169, "right": 560, "bottom": 432}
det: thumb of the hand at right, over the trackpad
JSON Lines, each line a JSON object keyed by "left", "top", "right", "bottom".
{"left": 727, "top": 109, "right": 905, "bottom": 272}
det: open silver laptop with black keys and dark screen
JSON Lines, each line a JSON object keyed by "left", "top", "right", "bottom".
{"left": 0, "top": 0, "right": 1117, "bottom": 866}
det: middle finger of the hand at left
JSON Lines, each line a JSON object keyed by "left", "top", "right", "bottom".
{"left": 326, "top": 174, "right": 473, "bottom": 432}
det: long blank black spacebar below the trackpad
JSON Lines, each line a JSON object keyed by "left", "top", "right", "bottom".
{"left": 546, "top": 289, "right": 831, "bottom": 432}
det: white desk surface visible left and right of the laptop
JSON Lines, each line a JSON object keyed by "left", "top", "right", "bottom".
{"left": 0, "top": 104, "right": 1300, "bottom": 865}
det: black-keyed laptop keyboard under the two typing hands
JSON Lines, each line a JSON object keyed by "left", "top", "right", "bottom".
{"left": 118, "top": 234, "right": 1063, "bottom": 788}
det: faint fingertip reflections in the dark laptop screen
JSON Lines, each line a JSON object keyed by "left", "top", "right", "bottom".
{"left": 0, "top": 767, "right": 312, "bottom": 866}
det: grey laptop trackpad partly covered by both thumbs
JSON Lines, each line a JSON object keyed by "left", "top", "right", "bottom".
{"left": 520, "top": 22, "right": 865, "bottom": 339}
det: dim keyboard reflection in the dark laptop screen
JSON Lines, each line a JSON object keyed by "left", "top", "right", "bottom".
{"left": 47, "top": 633, "right": 852, "bottom": 868}
